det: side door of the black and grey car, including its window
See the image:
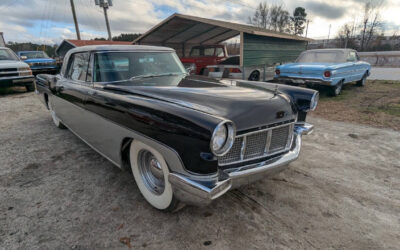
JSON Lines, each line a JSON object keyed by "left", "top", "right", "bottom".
{"left": 52, "top": 52, "right": 92, "bottom": 138}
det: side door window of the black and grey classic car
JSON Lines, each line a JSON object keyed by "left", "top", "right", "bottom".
{"left": 67, "top": 52, "right": 89, "bottom": 81}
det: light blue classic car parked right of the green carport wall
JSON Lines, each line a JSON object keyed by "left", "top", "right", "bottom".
{"left": 275, "top": 49, "right": 371, "bottom": 96}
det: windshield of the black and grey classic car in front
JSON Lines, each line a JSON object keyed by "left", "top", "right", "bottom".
{"left": 94, "top": 52, "right": 186, "bottom": 82}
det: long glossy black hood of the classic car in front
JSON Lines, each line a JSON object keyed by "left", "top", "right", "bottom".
{"left": 107, "top": 76, "right": 295, "bottom": 131}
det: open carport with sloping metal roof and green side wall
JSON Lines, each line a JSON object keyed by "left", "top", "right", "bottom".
{"left": 133, "top": 13, "right": 311, "bottom": 70}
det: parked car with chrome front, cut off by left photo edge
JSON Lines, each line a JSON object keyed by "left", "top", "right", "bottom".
{"left": 0, "top": 47, "right": 34, "bottom": 91}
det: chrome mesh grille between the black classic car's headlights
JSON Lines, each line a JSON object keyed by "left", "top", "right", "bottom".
{"left": 218, "top": 123, "right": 293, "bottom": 166}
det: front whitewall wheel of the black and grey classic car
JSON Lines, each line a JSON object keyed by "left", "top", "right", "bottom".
{"left": 129, "top": 140, "right": 181, "bottom": 211}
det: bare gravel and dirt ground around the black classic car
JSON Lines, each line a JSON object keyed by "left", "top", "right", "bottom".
{"left": 0, "top": 93, "right": 400, "bottom": 249}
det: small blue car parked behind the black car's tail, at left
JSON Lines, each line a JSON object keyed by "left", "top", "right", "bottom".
{"left": 18, "top": 51, "right": 58, "bottom": 75}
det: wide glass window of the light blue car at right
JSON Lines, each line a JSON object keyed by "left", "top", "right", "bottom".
{"left": 297, "top": 51, "right": 345, "bottom": 63}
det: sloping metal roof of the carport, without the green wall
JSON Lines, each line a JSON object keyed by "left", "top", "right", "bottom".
{"left": 133, "top": 13, "right": 312, "bottom": 44}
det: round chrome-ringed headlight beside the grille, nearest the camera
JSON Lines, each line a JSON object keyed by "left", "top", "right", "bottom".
{"left": 210, "top": 121, "right": 236, "bottom": 156}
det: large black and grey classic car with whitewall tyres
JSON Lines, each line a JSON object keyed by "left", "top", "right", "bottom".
{"left": 36, "top": 45, "right": 318, "bottom": 210}
